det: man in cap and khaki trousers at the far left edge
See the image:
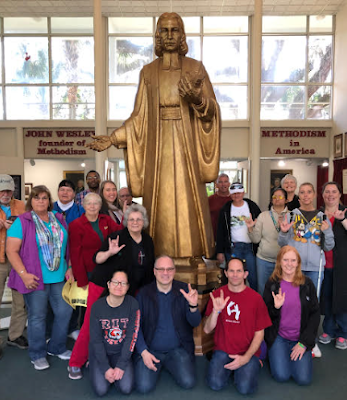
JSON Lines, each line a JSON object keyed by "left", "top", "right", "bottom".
{"left": 0, "top": 174, "right": 28, "bottom": 357}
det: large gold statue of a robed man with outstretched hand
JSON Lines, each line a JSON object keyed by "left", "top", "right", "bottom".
{"left": 88, "top": 13, "right": 221, "bottom": 265}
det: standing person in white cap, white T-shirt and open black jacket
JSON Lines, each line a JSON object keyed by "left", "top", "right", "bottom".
{"left": 216, "top": 182, "right": 261, "bottom": 291}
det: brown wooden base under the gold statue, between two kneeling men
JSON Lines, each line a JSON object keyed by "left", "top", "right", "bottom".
{"left": 174, "top": 258, "right": 222, "bottom": 356}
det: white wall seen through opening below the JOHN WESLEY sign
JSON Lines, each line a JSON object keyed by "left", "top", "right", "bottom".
{"left": 24, "top": 159, "right": 95, "bottom": 200}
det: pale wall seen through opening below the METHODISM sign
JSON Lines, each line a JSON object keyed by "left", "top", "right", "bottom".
{"left": 259, "top": 160, "right": 321, "bottom": 211}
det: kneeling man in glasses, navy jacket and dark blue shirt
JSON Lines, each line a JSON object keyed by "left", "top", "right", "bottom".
{"left": 135, "top": 256, "right": 201, "bottom": 393}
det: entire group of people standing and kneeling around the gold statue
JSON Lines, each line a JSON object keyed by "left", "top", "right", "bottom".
{"left": 0, "top": 171, "right": 347, "bottom": 396}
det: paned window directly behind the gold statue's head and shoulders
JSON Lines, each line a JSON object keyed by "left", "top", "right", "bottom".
{"left": 108, "top": 17, "right": 249, "bottom": 120}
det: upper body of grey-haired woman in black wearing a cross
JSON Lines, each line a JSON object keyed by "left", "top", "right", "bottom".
{"left": 93, "top": 204, "right": 154, "bottom": 296}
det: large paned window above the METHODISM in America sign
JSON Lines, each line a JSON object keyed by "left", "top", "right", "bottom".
{"left": 261, "top": 16, "right": 334, "bottom": 120}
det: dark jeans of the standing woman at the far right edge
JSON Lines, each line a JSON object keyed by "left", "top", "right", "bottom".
{"left": 322, "top": 268, "right": 347, "bottom": 339}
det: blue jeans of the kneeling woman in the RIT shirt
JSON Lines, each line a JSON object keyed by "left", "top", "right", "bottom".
{"left": 89, "top": 352, "right": 134, "bottom": 396}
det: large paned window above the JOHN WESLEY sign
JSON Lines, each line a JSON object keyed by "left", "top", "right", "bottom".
{"left": 0, "top": 18, "right": 95, "bottom": 120}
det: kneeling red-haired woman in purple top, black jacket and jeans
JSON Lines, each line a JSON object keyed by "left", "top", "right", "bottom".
{"left": 263, "top": 246, "right": 320, "bottom": 385}
